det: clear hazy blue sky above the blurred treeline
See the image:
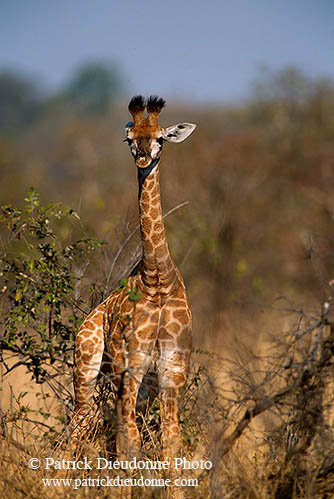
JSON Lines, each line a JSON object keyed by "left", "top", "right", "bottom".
{"left": 0, "top": 0, "right": 334, "bottom": 102}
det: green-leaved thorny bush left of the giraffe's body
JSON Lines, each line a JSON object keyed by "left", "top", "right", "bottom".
{"left": 0, "top": 188, "right": 103, "bottom": 383}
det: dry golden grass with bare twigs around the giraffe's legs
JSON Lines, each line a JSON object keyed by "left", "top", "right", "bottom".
{"left": 0, "top": 310, "right": 334, "bottom": 499}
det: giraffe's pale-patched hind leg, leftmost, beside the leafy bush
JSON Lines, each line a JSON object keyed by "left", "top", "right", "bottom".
{"left": 70, "top": 321, "right": 104, "bottom": 443}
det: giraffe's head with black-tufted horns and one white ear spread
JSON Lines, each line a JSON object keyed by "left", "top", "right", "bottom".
{"left": 125, "top": 95, "right": 196, "bottom": 169}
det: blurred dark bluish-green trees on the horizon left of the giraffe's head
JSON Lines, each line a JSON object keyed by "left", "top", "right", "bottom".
{"left": 0, "top": 61, "right": 124, "bottom": 134}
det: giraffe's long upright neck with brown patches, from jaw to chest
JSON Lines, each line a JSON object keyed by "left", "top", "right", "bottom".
{"left": 138, "top": 160, "right": 180, "bottom": 298}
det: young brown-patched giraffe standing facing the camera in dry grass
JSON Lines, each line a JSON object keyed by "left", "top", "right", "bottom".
{"left": 71, "top": 96, "right": 196, "bottom": 459}
